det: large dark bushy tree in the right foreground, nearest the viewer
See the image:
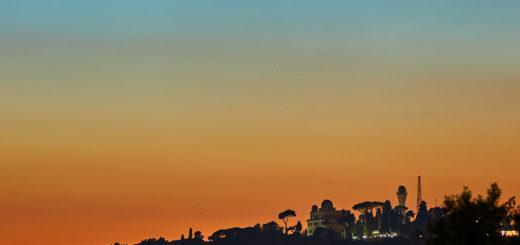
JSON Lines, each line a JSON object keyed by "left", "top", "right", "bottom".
{"left": 427, "top": 183, "right": 514, "bottom": 245}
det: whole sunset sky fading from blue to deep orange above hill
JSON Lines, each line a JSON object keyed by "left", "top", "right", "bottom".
{"left": 0, "top": 0, "right": 520, "bottom": 245}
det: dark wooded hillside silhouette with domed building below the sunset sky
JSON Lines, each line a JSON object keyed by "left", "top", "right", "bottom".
{"left": 114, "top": 183, "right": 520, "bottom": 245}
